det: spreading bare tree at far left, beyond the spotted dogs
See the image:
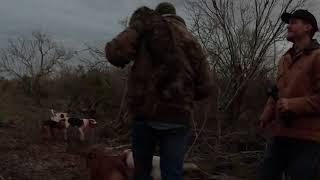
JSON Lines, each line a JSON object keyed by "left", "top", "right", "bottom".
{"left": 0, "top": 32, "right": 73, "bottom": 103}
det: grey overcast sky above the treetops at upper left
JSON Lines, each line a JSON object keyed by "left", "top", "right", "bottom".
{"left": 0, "top": 0, "right": 183, "bottom": 46}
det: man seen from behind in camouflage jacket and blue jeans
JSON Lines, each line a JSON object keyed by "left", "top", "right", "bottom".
{"left": 105, "top": 2, "right": 213, "bottom": 180}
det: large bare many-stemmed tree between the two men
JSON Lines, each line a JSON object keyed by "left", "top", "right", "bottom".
{"left": 186, "top": 0, "right": 307, "bottom": 126}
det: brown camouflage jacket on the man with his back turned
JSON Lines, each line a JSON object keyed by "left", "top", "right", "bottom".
{"left": 105, "top": 9, "right": 212, "bottom": 125}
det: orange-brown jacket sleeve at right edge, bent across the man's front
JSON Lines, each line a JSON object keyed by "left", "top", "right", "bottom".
{"left": 288, "top": 56, "right": 320, "bottom": 115}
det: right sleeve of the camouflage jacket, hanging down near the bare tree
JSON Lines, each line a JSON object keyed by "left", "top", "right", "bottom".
{"left": 190, "top": 42, "right": 214, "bottom": 101}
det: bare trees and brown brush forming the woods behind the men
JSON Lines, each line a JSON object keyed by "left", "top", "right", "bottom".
{"left": 0, "top": 0, "right": 318, "bottom": 179}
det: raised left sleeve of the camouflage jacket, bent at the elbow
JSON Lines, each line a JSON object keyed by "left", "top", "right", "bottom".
{"left": 105, "top": 27, "right": 139, "bottom": 68}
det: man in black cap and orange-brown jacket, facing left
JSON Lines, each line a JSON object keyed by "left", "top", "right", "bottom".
{"left": 258, "top": 9, "right": 320, "bottom": 180}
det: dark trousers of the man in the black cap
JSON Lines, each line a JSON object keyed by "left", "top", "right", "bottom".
{"left": 257, "top": 137, "right": 320, "bottom": 180}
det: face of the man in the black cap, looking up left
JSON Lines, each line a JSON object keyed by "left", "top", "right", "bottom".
{"left": 287, "top": 18, "right": 312, "bottom": 42}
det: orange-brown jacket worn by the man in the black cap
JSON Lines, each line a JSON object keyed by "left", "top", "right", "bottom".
{"left": 260, "top": 40, "right": 320, "bottom": 142}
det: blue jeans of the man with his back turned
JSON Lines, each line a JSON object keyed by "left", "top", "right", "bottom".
{"left": 132, "top": 120, "right": 189, "bottom": 180}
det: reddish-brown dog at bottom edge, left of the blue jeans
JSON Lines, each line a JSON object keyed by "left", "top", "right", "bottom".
{"left": 86, "top": 145, "right": 129, "bottom": 180}
